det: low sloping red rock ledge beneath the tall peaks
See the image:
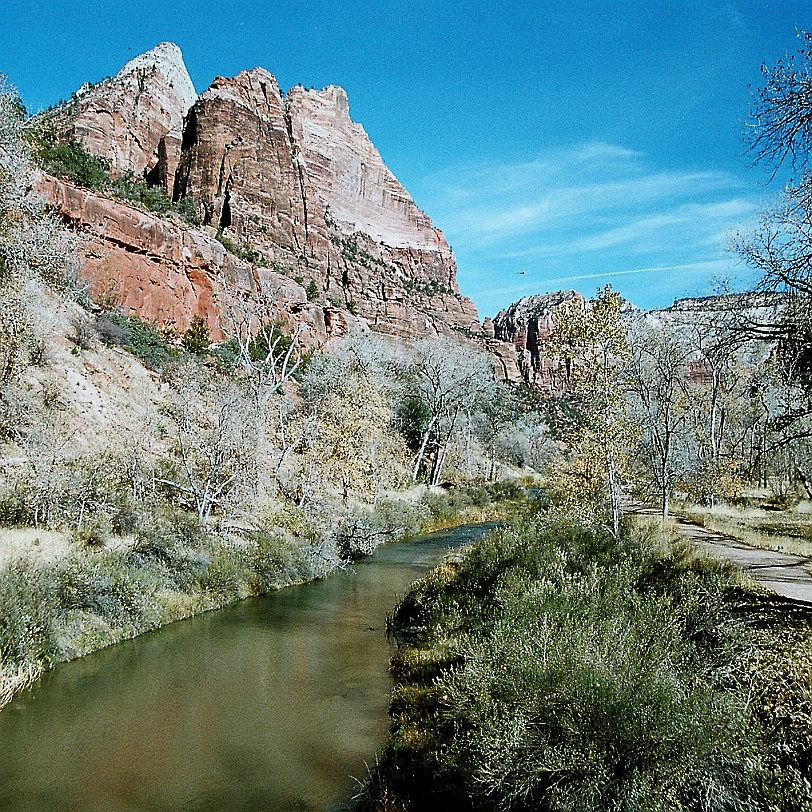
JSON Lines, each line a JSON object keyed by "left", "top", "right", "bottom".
{"left": 35, "top": 175, "right": 364, "bottom": 348}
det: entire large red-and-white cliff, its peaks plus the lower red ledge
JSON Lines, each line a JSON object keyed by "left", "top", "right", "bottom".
{"left": 39, "top": 43, "right": 480, "bottom": 338}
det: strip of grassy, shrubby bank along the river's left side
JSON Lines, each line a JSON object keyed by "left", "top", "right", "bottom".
{"left": 0, "top": 486, "right": 522, "bottom": 708}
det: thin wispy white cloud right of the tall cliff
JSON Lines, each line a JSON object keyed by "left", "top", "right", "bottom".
{"left": 421, "top": 142, "right": 759, "bottom": 312}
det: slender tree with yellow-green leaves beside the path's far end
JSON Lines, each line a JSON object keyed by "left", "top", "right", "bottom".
{"left": 544, "top": 285, "right": 633, "bottom": 534}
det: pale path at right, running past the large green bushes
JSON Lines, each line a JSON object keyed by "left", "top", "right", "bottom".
{"left": 631, "top": 505, "right": 812, "bottom": 606}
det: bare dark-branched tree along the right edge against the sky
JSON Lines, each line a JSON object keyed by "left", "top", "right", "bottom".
{"left": 733, "top": 39, "right": 812, "bottom": 502}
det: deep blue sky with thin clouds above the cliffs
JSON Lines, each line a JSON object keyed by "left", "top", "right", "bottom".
{"left": 0, "top": 0, "right": 812, "bottom": 316}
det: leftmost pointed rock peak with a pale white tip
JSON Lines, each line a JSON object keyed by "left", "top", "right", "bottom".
{"left": 47, "top": 42, "right": 197, "bottom": 182}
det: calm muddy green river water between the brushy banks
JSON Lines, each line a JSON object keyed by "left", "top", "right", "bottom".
{"left": 0, "top": 526, "right": 494, "bottom": 812}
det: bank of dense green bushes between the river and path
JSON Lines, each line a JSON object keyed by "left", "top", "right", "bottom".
{"left": 361, "top": 518, "right": 812, "bottom": 810}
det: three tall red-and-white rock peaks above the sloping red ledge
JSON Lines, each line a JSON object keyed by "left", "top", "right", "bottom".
{"left": 44, "top": 44, "right": 480, "bottom": 338}
